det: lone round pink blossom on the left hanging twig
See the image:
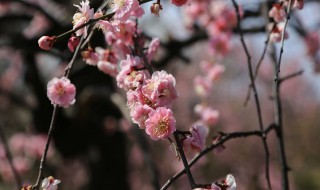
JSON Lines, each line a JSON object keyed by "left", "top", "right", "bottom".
{"left": 47, "top": 77, "right": 76, "bottom": 107}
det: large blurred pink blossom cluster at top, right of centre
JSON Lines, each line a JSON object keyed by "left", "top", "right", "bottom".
{"left": 185, "top": 0, "right": 237, "bottom": 56}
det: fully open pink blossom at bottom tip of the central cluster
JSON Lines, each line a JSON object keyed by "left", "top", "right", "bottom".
{"left": 145, "top": 107, "right": 176, "bottom": 140}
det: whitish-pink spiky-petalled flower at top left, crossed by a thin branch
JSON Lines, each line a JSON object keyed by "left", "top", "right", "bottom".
{"left": 72, "top": 0, "right": 94, "bottom": 37}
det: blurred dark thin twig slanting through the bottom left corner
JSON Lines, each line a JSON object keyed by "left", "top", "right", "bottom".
{"left": 0, "top": 122, "right": 22, "bottom": 189}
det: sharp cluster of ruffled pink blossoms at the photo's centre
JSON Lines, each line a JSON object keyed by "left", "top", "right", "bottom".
{"left": 117, "top": 66, "right": 178, "bottom": 140}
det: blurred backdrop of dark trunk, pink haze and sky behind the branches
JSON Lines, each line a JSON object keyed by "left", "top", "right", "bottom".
{"left": 0, "top": 0, "right": 320, "bottom": 190}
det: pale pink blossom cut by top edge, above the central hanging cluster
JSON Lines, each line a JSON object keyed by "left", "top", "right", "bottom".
{"left": 113, "top": 0, "right": 141, "bottom": 21}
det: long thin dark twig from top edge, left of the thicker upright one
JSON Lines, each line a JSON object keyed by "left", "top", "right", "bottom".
{"left": 232, "top": 0, "right": 272, "bottom": 190}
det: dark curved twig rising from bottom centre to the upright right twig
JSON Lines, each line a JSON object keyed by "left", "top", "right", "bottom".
{"left": 161, "top": 124, "right": 276, "bottom": 190}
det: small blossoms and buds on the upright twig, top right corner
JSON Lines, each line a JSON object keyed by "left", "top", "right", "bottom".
{"left": 269, "top": 0, "right": 304, "bottom": 42}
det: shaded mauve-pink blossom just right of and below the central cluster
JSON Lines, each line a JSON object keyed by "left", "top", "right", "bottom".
{"left": 183, "top": 125, "right": 208, "bottom": 152}
